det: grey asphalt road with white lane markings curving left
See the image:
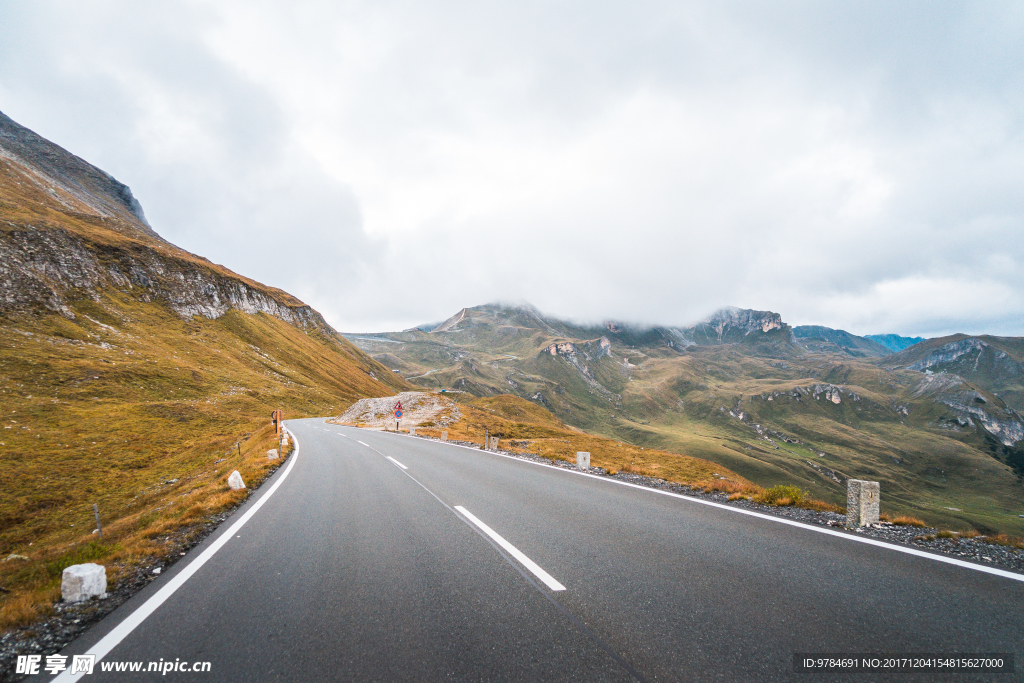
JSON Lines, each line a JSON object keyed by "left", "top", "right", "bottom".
{"left": 39, "top": 420, "right": 1024, "bottom": 682}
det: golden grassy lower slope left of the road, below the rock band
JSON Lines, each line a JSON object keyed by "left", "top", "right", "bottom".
{"left": 0, "top": 293, "right": 407, "bottom": 630}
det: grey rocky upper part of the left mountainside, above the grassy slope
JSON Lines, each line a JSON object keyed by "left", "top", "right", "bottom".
{"left": 0, "top": 114, "right": 337, "bottom": 335}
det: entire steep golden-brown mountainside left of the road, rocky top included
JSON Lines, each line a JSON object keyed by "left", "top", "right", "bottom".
{"left": 0, "top": 115, "right": 410, "bottom": 628}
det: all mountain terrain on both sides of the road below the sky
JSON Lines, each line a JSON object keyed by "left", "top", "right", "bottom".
{"left": 0, "top": 105, "right": 1024, "bottom": 629}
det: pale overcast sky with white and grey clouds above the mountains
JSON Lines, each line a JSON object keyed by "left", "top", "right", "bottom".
{"left": 0, "top": 0, "right": 1024, "bottom": 336}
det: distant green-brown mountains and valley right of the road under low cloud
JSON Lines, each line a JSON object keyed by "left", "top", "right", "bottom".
{"left": 353, "top": 304, "right": 1024, "bottom": 533}
